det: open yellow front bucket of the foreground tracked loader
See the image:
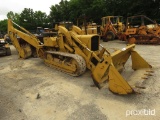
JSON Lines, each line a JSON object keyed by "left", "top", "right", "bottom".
{"left": 92, "top": 44, "right": 152, "bottom": 94}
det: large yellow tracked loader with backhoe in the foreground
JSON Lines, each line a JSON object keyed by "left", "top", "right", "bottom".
{"left": 8, "top": 19, "right": 151, "bottom": 94}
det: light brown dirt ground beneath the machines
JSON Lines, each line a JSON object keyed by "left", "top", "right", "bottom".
{"left": 0, "top": 40, "right": 160, "bottom": 120}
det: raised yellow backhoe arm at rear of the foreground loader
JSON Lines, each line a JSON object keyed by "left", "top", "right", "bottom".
{"left": 8, "top": 19, "right": 41, "bottom": 58}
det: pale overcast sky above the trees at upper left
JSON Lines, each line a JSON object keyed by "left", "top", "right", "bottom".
{"left": 0, "top": 0, "right": 61, "bottom": 20}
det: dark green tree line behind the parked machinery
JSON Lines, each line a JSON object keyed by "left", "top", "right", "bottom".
{"left": 0, "top": 0, "right": 160, "bottom": 31}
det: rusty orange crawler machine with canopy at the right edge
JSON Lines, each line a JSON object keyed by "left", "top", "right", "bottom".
{"left": 122, "top": 15, "right": 160, "bottom": 44}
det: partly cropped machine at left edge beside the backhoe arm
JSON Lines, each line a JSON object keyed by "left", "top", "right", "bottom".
{"left": 0, "top": 38, "right": 11, "bottom": 56}
